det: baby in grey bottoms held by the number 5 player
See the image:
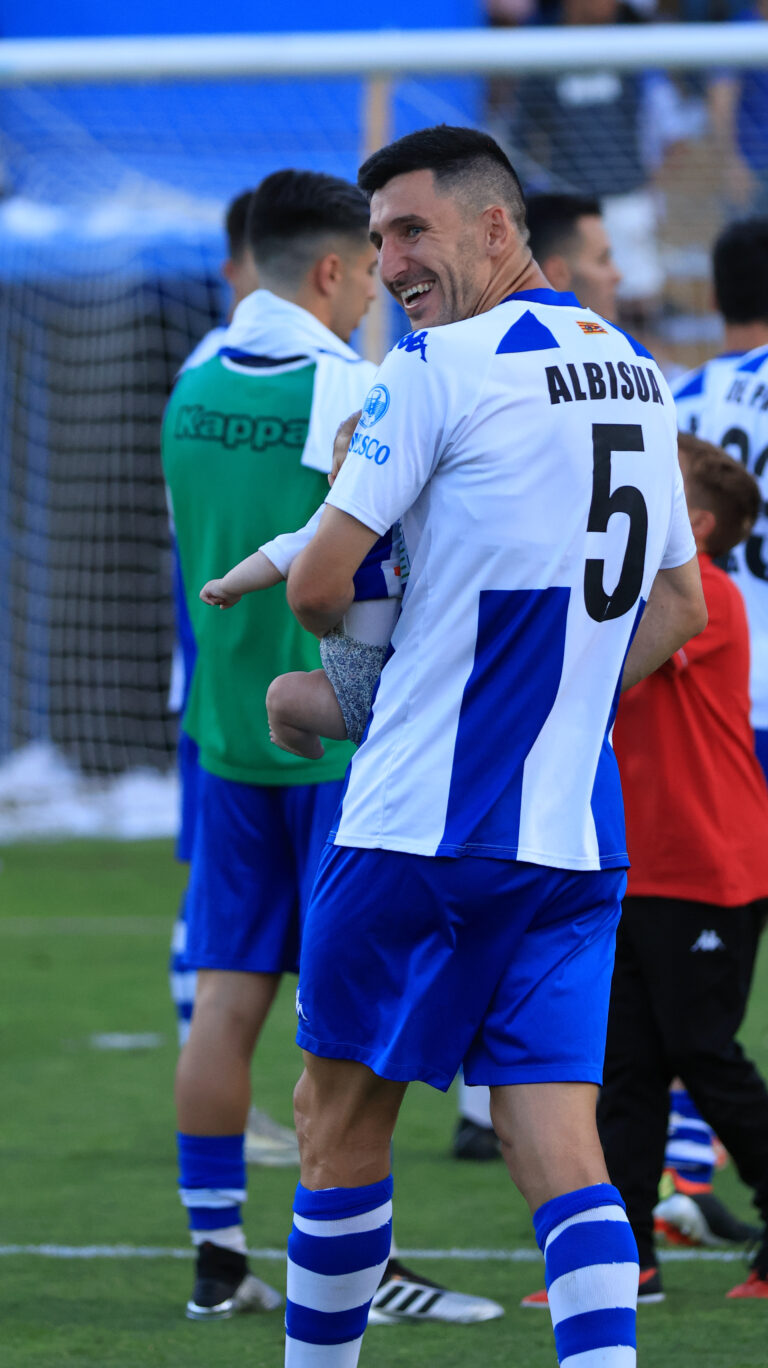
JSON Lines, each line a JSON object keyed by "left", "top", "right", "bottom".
{"left": 200, "top": 424, "right": 408, "bottom": 759}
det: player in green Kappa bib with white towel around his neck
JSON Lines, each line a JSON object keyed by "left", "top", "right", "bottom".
{"left": 163, "top": 171, "right": 375, "bottom": 1319}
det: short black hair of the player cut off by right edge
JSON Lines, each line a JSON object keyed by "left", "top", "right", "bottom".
{"left": 712, "top": 218, "right": 768, "bottom": 323}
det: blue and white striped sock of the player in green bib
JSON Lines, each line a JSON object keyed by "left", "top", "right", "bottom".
{"left": 177, "top": 1131, "right": 245, "bottom": 1254}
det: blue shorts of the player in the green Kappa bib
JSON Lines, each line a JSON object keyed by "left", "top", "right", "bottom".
{"left": 185, "top": 767, "right": 342, "bottom": 974}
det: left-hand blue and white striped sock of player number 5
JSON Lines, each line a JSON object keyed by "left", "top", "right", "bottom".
{"left": 285, "top": 1178, "right": 392, "bottom": 1368}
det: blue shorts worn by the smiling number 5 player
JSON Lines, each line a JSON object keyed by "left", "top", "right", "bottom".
{"left": 297, "top": 844, "right": 627, "bottom": 1090}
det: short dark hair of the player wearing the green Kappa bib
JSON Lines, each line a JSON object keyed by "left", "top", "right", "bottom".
{"left": 246, "top": 171, "right": 368, "bottom": 279}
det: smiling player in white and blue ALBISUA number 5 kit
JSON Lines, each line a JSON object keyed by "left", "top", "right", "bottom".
{"left": 276, "top": 127, "right": 705, "bottom": 1368}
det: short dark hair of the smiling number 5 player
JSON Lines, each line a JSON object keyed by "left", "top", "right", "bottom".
{"left": 357, "top": 123, "right": 526, "bottom": 235}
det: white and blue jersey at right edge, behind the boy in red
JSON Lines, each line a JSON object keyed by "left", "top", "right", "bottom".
{"left": 674, "top": 346, "right": 768, "bottom": 729}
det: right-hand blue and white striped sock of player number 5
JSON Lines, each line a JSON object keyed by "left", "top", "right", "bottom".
{"left": 534, "top": 1183, "right": 639, "bottom": 1368}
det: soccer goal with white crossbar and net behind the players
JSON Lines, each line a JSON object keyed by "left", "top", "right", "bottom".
{"left": 0, "top": 23, "right": 768, "bottom": 840}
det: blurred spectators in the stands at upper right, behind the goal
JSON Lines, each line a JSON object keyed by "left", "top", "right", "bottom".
{"left": 486, "top": 0, "right": 768, "bottom": 371}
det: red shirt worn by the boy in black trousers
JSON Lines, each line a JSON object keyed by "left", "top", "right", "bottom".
{"left": 613, "top": 555, "right": 768, "bottom": 907}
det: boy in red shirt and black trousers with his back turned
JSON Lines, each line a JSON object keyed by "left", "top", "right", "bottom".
{"left": 598, "top": 434, "right": 768, "bottom": 1301}
